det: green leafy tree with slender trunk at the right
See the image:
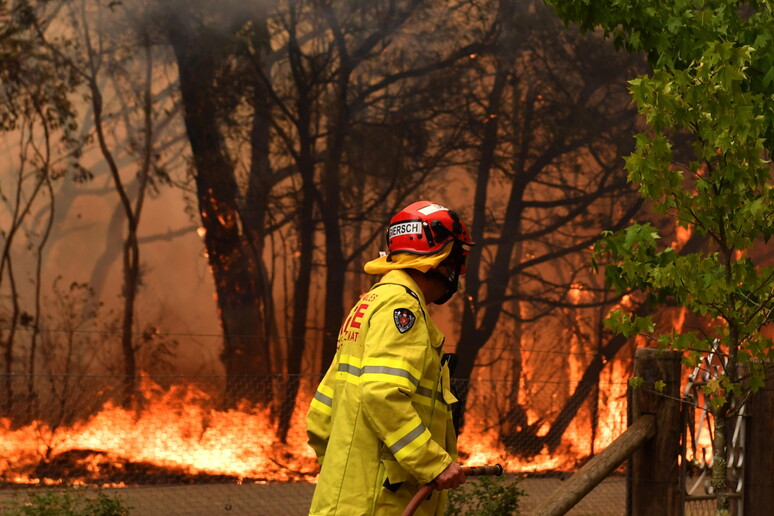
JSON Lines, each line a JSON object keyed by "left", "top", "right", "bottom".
{"left": 555, "top": 0, "right": 774, "bottom": 512}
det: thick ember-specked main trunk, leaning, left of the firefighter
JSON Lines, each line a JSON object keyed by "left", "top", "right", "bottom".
{"left": 167, "top": 18, "right": 273, "bottom": 407}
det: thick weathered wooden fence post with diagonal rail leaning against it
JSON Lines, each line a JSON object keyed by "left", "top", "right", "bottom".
{"left": 628, "top": 348, "right": 683, "bottom": 516}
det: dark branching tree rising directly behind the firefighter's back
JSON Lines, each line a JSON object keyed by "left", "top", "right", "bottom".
{"left": 259, "top": 1, "right": 492, "bottom": 439}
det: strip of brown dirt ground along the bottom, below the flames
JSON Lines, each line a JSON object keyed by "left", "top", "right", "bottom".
{"left": 0, "top": 477, "right": 626, "bottom": 516}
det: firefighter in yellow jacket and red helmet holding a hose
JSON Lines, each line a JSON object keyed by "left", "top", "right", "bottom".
{"left": 306, "top": 201, "right": 473, "bottom": 516}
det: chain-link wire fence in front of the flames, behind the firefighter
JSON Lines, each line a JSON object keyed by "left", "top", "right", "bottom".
{"left": 0, "top": 375, "right": 716, "bottom": 516}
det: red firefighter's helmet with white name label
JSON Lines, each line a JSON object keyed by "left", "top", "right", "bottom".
{"left": 387, "top": 201, "right": 474, "bottom": 254}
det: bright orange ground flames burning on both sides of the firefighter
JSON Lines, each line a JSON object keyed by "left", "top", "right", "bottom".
{"left": 0, "top": 363, "right": 627, "bottom": 487}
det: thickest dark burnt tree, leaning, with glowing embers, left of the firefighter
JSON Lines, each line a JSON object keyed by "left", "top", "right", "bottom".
{"left": 163, "top": 6, "right": 273, "bottom": 405}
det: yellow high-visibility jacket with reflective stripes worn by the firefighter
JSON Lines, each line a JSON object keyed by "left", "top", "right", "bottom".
{"left": 306, "top": 270, "right": 457, "bottom": 516}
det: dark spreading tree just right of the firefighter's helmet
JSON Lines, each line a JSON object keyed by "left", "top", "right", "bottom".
{"left": 456, "top": 2, "right": 641, "bottom": 440}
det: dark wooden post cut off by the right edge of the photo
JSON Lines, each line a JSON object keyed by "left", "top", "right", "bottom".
{"left": 743, "top": 364, "right": 774, "bottom": 515}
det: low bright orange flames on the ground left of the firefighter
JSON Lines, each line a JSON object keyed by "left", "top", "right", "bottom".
{"left": 0, "top": 377, "right": 317, "bottom": 485}
